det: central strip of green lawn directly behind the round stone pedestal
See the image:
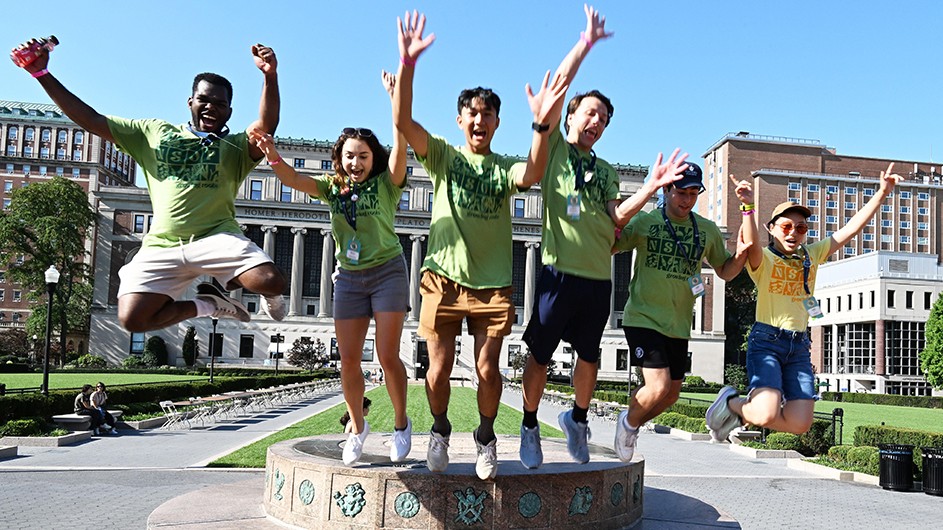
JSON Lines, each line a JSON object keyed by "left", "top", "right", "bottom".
{"left": 210, "top": 385, "right": 563, "bottom": 467}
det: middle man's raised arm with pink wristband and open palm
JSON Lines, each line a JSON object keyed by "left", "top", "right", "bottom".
{"left": 393, "top": 11, "right": 435, "bottom": 157}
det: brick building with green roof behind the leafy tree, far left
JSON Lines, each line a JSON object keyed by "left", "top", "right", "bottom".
{"left": 0, "top": 100, "right": 136, "bottom": 352}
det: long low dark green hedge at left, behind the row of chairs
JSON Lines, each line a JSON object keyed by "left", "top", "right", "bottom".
{"left": 0, "top": 372, "right": 318, "bottom": 423}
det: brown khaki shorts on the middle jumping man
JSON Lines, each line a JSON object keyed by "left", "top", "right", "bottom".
{"left": 419, "top": 270, "right": 514, "bottom": 340}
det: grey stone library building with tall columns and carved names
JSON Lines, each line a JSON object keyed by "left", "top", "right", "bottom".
{"left": 90, "top": 138, "right": 724, "bottom": 381}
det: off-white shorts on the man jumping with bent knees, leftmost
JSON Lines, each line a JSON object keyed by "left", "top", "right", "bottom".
{"left": 118, "top": 233, "right": 272, "bottom": 300}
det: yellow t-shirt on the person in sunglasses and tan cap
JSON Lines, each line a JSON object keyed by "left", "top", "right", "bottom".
{"left": 747, "top": 238, "right": 832, "bottom": 331}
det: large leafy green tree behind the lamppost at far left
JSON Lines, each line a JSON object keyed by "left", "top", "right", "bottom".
{"left": 0, "top": 176, "right": 97, "bottom": 362}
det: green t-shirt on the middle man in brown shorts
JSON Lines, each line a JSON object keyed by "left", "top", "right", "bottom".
{"left": 418, "top": 134, "right": 526, "bottom": 289}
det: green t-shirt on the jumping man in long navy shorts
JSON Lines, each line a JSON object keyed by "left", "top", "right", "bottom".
{"left": 540, "top": 129, "right": 619, "bottom": 280}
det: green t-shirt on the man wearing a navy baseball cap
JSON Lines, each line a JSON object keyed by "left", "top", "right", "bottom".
{"left": 615, "top": 209, "right": 730, "bottom": 339}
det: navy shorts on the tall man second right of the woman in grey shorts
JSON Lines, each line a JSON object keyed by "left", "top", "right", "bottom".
{"left": 523, "top": 265, "right": 612, "bottom": 366}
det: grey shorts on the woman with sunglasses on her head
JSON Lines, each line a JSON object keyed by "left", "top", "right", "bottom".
{"left": 334, "top": 254, "right": 409, "bottom": 320}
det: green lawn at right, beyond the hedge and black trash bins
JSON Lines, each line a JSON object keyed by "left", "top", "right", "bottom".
{"left": 681, "top": 392, "right": 943, "bottom": 438}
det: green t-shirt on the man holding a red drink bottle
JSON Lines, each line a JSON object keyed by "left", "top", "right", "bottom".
{"left": 107, "top": 116, "right": 258, "bottom": 247}
